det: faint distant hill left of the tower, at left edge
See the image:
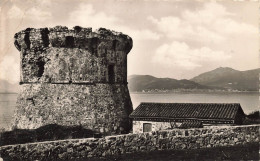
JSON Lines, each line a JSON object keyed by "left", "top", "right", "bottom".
{"left": 0, "top": 79, "right": 19, "bottom": 93}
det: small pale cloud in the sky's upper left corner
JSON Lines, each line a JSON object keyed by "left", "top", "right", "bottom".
{"left": 7, "top": 5, "right": 52, "bottom": 21}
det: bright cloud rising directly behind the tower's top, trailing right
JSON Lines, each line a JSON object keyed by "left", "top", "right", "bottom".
{"left": 69, "top": 3, "right": 161, "bottom": 40}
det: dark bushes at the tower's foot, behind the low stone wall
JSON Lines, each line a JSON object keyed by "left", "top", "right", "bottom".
{"left": 0, "top": 124, "right": 94, "bottom": 146}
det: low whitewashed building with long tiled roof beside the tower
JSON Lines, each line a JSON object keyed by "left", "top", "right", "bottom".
{"left": 130, "top": 103, "right": 245, "bottom": 133}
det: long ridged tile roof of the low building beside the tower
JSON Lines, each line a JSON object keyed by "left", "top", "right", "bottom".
{"left": 130, "top": 103, "right": 244, "bottom": 120}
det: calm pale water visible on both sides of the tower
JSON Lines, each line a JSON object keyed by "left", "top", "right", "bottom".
{"left": 0, "top": 92, "right": 259, "bottom": 128}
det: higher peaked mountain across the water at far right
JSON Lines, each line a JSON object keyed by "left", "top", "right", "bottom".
{"left": 190, "top": 67, "right": 260, "bottom": 91}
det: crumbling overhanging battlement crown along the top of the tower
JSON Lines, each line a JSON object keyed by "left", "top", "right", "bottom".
{"left": 14, "top": 26, "right": 133, "bottom": 53}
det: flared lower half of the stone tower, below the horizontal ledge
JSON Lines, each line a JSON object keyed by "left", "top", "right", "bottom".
{"left": 12, "top": 84, "right": 131, "bottom": 134}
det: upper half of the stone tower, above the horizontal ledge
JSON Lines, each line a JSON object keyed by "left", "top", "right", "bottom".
{"left": 14, "top": 26, "right": 133, "bottom": 83}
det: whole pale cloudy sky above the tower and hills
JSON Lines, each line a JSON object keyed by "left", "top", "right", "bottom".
{"left": 0, "top": 0, "right": 259, "bottom": 83}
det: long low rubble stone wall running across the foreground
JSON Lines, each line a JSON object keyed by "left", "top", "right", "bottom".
{"left": 0, "top": 125, "right": 260, "bottom": 160}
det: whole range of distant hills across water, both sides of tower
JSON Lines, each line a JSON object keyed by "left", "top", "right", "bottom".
{"left": 0, "top": 67, "right": 260, "bottom": 93}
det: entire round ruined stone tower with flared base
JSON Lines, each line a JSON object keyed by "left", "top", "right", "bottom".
{"left": 14, "top": 26, "right": 133, "bottom": 134}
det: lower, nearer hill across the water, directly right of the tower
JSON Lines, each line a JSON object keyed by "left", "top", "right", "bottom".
{"left": 128, "top": 75, "right": 208, "bottom": 91}
